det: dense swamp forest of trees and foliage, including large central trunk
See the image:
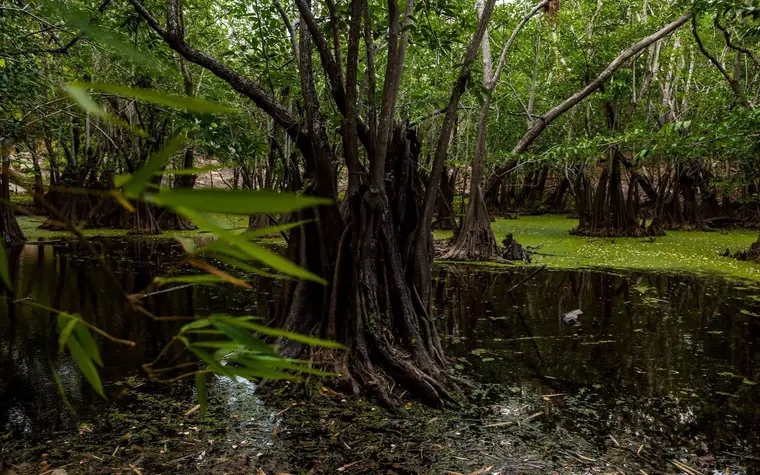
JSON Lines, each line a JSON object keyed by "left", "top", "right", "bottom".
{"left": 0, "top": 0, "right": 760, "bottom": 405}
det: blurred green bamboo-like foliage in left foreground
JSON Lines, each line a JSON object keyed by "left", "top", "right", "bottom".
{"left": 0, "top": 84, "right": 343, "bottom": 410}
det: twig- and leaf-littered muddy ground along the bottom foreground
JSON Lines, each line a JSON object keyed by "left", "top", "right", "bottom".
{"left": 0, "top": 379, "right": 712, "bottom": 475}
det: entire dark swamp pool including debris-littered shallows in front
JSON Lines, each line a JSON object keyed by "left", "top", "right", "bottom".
{"left": 0, "top": 240, "right": 760, "bottom": 474}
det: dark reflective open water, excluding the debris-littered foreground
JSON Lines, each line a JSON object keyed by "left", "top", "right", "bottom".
{"left": 0, "top": 240, "right": 760, "bottom": 473}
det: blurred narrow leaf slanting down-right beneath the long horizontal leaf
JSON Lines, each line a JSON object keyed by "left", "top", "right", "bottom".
{"left": 175, "top": 206, "right": 327, "bottom": 284}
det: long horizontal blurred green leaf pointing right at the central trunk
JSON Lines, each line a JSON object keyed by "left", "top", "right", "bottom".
{"left": 150, "top": 188, "right": 332, "bottom": 216}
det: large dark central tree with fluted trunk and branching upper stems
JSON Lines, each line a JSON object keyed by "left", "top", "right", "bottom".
{"left": 130, "top": 0, "right": 495, "bottom": 405}
